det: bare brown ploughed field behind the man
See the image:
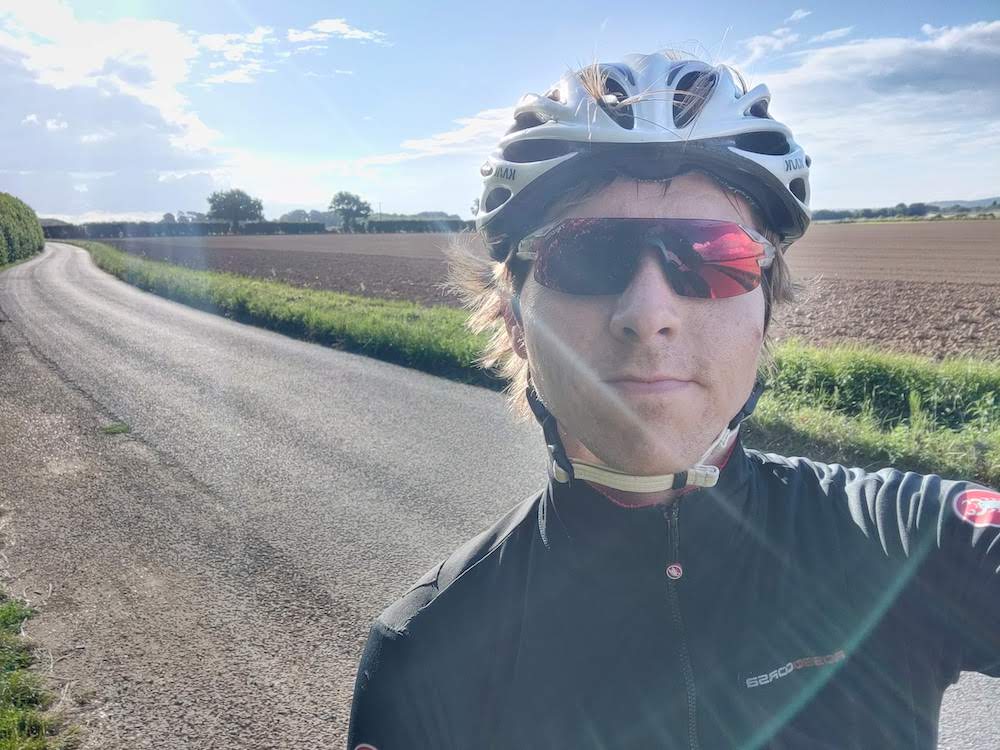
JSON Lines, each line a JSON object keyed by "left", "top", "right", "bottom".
{"left": 105, "top": 221, "right": 1000, "bottom": 358}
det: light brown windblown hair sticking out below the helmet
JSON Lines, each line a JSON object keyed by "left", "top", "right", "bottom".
{"left": 443, "top": 175, "right": 794, "bottom": 421}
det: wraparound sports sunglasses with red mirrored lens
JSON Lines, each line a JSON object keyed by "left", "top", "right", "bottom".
{"left": 514, "top": 218, "right": 777, "bottom": 299}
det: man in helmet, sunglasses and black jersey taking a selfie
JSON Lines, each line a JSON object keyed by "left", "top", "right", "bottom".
{"left": 348, "top": 54, "right": 1000, "bottom": 750}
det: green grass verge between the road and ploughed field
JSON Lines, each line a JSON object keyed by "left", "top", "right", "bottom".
{"left": 73, "top": 242, "right": 1000, "bottom": 486}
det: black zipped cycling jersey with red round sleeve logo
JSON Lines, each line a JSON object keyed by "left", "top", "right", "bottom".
{"left": 348, "top": 443, "right": 1000, "bottom": 750}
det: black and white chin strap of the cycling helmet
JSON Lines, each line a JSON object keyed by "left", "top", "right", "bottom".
{"left": 527, "top": 380, "right": 764, "bottom": 492}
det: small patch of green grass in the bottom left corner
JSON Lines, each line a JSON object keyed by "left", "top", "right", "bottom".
{"left": 0, "top": 594, "right": 79, "bottom": 750}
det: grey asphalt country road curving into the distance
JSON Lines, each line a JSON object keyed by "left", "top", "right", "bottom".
{"left": 0, "top": 244, "right": 1000, "bottom": 749}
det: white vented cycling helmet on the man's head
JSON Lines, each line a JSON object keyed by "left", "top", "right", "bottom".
{"left": 476, "top": 53, "right": 811, "bottom": 261}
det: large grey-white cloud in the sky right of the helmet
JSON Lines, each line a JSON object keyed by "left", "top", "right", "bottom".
{"left": 766, "top": 21, "right": 1000, "bottom": 208}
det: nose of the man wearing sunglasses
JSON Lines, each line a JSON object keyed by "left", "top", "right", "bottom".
{"left": 611, "top": 248, "right": 683, "bottom": 343}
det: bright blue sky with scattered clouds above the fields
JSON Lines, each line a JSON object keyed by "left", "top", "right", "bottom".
{"left": 0, "top": 0, "right": 1000, "bottom": 221}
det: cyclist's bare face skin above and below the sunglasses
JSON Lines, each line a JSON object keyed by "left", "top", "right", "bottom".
{"left": 508, "top": 173, "right": 764, "bottom": 475}
